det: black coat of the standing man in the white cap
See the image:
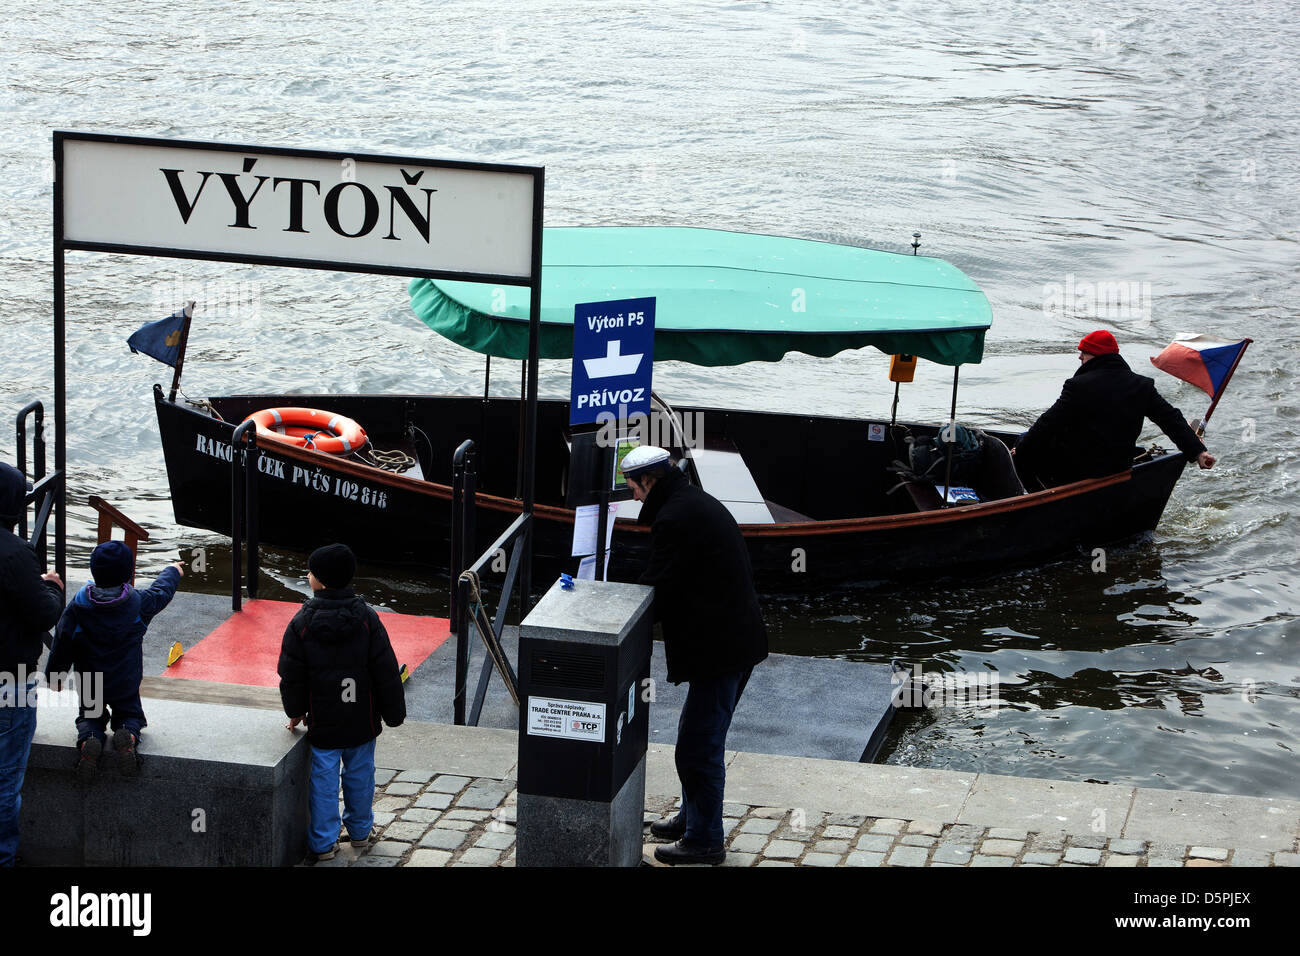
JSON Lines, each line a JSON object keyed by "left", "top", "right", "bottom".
{"left": 638, "top": 471, "right": 767, "bottom": 684}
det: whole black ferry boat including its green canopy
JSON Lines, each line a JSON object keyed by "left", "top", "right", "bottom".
{"left": 153, "top": 226, "right": 1186, "bottom": 593}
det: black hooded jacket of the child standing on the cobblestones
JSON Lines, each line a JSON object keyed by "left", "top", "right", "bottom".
{"left": 278, "top": 588, "right": 406, "bottom": 750}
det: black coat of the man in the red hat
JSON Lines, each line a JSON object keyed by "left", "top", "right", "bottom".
{"left": 1015, "top": 355, "right": 1205, "bottom": 490}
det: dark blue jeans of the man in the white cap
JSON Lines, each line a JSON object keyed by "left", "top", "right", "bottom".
{"left": 676, "top": 667, "right": 754, "bottom": 847}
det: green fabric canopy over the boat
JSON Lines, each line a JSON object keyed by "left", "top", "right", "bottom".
{"left": 410, "top": 226, "right": 992, "bottom": 365}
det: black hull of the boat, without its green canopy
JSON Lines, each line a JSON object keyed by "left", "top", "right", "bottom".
{"left": 155, "top": 393, "right": 1184, "bottom": 593}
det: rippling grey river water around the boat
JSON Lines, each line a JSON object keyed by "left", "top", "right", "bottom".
{"left": 0, "top": 0, "right": 1300, "bottom": 797}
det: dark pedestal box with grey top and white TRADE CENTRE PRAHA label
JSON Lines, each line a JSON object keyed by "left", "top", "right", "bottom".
{"left": 516, "top": 580, "right": 654, "bottom": 866}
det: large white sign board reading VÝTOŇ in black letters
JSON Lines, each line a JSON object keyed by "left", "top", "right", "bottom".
{"left": 56, "top": 134, "right": 541, "bottom": 284}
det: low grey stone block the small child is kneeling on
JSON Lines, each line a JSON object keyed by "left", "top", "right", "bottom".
{"left": 22, "top": 697, "right": 312, "bottom": 866}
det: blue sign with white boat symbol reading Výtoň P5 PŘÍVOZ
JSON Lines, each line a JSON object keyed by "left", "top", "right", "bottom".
{"left": 569, "top": 297, "right": 655, "bottom": 425}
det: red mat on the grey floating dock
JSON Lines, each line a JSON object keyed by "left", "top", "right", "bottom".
{"left": 163, "top": 601, "right": 451, "bottom": 687}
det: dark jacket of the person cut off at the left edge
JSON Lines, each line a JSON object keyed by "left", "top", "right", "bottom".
{"left": 0, "top": 528, "right": 64, "bottom": 676}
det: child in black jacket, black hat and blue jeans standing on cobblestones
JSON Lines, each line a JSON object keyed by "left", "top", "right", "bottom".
{"left": 278, "top": 545, "right": 406, "bottom": 861}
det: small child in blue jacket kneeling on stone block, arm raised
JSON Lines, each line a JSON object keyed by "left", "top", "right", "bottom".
{"left": 46, "top": 541, "right": 185, "bottom": 782}
